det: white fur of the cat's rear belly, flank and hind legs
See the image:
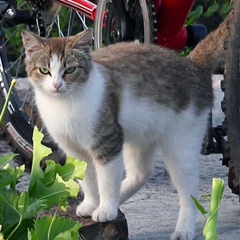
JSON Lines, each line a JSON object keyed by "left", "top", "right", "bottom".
{"left": 119, "top": 92, "right": 210, "bottom": 240}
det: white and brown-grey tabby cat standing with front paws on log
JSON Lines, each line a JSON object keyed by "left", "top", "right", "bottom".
{"left": 22, "top": 13, "right": 227, "bottom": 240}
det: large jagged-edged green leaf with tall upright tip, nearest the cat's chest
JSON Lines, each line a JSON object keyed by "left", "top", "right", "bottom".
{"left": 29, "top": 127, "right": 86, "bottom": 207}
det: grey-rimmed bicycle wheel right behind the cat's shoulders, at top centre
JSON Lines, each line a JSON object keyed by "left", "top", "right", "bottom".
{"left": 94, "top": 0, "right": 157, "bottom": 49}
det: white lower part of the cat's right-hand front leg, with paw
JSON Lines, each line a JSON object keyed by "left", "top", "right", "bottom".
{"left": 92, "top": 153, "right": 123, "bottom": 222}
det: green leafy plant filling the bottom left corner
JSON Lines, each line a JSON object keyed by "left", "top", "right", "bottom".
{"left": 0, "top": 128, "right": 86, "bottom": 240}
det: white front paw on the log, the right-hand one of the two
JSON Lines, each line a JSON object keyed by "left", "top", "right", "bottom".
{"left": 92, "top": 207, "right": 118, "bottom": 222}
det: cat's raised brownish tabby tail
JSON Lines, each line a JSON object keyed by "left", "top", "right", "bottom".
{"left": 188, "top": 12, "right": 233, "bottom": 72}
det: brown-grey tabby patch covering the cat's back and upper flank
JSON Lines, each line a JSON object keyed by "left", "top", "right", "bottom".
{"left": 92, "top": 43, "right": 213, "bottom": 109}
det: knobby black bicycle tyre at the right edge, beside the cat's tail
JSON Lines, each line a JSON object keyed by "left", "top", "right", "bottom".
{"left": 222, "top": 0, "right": 240, "bottom": 194}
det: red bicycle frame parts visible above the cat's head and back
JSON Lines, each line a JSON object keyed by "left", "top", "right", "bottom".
{"left": 55, "top": 0, "right": 194, "bottom": 50}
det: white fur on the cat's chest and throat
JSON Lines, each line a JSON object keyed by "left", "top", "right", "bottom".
{"left": 35, "top": 61, "right": 104, "bottom": 151}
